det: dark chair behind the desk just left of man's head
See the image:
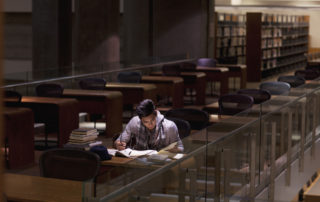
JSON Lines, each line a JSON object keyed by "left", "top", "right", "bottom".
{"left": 79, "top": 78, "right": 107, "bottom": 128}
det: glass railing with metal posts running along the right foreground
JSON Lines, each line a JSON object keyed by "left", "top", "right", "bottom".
{"left": 80, "top": 83, "right": 320, "bottom": 202}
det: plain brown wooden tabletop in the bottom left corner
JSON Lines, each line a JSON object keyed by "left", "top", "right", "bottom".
{"left": 4, "top": 173, "right": 82, "bottom": 202}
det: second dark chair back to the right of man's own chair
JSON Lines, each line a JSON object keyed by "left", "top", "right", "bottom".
{"left": 218, "top": 94, "right": 254, "bottom": 115}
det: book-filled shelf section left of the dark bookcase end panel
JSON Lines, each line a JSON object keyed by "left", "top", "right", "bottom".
{"left": 215, "top": 12, "right": 246, "bottom": 64}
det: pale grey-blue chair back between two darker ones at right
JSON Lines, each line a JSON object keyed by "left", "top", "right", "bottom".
{"left": 259, "top": 81, "right": 291, "bottom": 95}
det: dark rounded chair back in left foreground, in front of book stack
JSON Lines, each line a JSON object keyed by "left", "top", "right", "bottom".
{"left": 39, "top": 148, "right": 100, "bottom": 181}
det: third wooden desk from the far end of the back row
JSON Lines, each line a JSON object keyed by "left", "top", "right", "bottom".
{"left": 150, "top": 71, "right": 206, "bottom": 105}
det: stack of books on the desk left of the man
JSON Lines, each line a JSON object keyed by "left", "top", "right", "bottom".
{"left": 65, "top": 128, "right": 102, "bottom": 150}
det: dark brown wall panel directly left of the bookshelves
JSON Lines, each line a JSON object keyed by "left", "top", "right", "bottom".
{"left": 153, "top": 0, "right": 207, "bottom": 57}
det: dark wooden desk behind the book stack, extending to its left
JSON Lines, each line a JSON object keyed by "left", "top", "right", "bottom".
{"left": 6, "top": 96, "right": 79, "bottom": 147}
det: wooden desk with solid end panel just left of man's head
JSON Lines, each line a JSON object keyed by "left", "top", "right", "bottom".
{"left": 63, "top": 89, "right": 123, "bottom": 137}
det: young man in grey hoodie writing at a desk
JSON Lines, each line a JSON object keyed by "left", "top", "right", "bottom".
{"left": 114, "top": 99, "right": 183, "bottom": 152}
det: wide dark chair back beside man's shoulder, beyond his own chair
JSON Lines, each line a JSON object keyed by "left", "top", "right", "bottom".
{"left": 165, "top": 108, "right": 209, "bottom": 130}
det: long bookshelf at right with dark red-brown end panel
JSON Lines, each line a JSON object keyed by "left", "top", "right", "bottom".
{"left": 246, "top": 13, "right": 309, "bottom": 81}
